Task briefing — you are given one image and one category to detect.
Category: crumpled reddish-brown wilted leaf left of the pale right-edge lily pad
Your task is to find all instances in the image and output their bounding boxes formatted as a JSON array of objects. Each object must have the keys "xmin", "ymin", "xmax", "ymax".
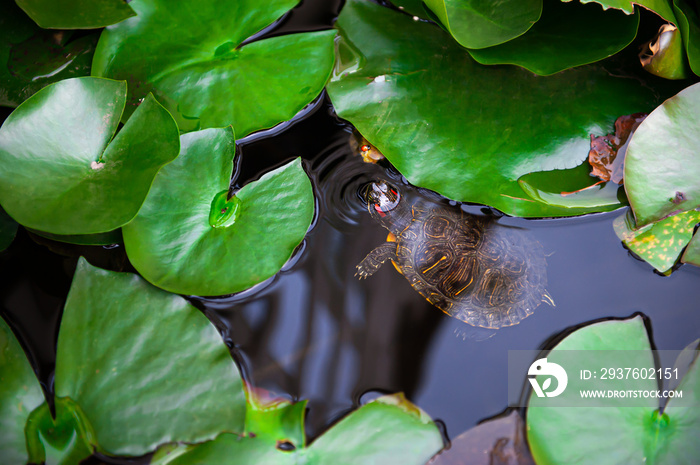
[{"xmin": 588, "ymin": 113, "xmax": 647, "ymax": 184}]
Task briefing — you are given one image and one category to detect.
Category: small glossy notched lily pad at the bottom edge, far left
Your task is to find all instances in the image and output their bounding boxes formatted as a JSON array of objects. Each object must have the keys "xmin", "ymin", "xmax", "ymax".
[{"xmin": 26, "ymin": 399, "xmax": 97, "ymax": 465}]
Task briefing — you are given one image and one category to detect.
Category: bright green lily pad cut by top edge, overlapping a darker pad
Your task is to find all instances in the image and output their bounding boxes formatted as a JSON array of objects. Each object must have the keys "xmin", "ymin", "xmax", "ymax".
[{"xmin": 424, "ymin": 0, "xmax": 542, "ymax": 48}]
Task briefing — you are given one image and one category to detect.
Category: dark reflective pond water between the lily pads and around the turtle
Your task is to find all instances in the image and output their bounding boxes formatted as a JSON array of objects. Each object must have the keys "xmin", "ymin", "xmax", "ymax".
[{"xmin": 0, "ymin": 0, "xmax": 700, "ymax": 460}]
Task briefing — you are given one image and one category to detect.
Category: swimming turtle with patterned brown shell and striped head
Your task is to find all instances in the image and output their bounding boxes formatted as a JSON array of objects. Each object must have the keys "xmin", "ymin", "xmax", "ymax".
[{"xmin": 357, "ymin": 181, "xmax": 553, "ymax": 329}]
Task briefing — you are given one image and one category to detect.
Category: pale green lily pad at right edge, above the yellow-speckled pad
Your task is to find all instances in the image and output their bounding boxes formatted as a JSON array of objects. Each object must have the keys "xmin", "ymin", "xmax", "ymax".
[{"xmin": 624, "ymin": 84, "xmax": 700, "ymax": 226}]
